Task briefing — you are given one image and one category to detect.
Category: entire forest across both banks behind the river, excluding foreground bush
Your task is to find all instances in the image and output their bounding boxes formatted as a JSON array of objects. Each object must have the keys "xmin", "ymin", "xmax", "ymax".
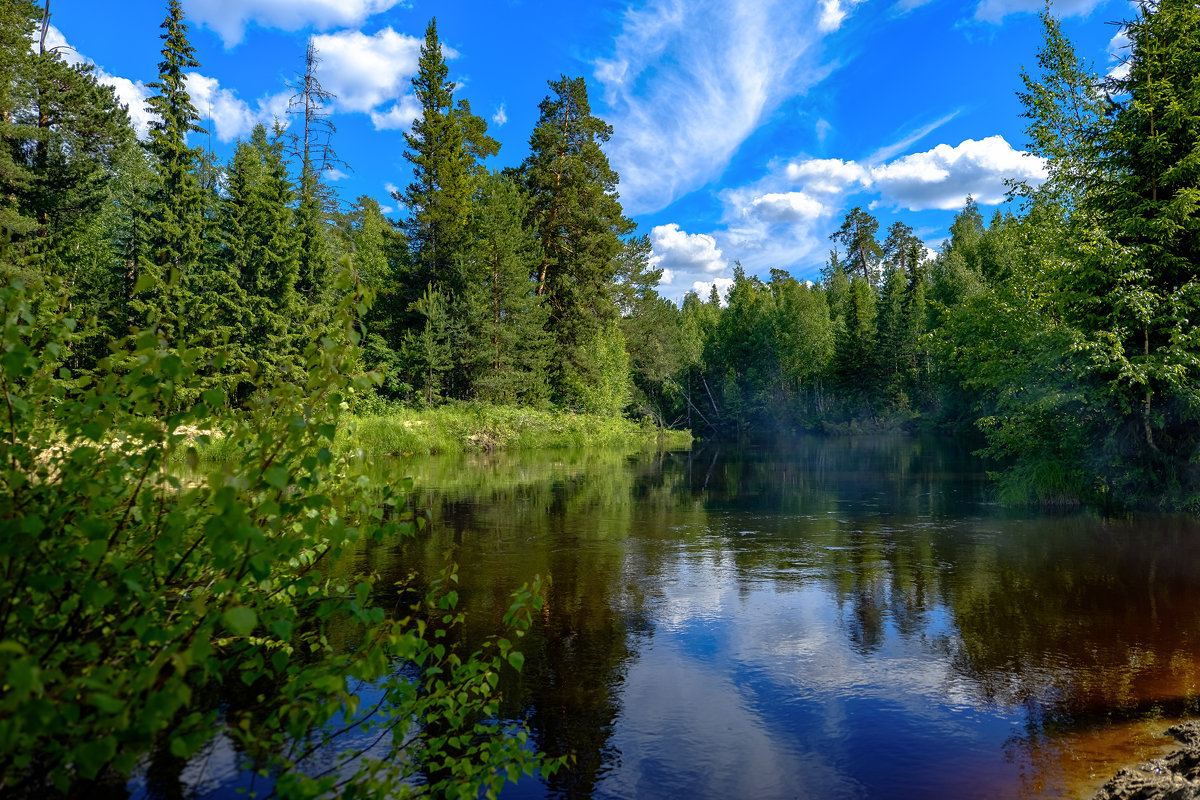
[{"xmin": 7, "ymin": 0, "xmax": 1200, "ymax": 510}]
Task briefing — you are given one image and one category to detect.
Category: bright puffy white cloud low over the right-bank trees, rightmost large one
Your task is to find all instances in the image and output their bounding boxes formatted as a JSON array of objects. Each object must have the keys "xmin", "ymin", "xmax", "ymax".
[{"xmin": 871, "ymin": 136, "xmax": 1045, "ymax": 211}]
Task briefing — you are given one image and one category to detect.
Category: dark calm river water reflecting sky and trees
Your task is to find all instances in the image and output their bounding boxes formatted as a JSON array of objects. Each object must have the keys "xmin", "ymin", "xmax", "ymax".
[{"xmin": 379, "ymin": 438, "xmax": 1200, "ymax": 799}]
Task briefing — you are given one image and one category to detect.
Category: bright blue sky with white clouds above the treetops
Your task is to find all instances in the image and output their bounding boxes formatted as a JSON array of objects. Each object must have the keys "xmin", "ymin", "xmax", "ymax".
[{"xmin": 50, "ymin": 0, "xmax": 1130, "ymax": 300}]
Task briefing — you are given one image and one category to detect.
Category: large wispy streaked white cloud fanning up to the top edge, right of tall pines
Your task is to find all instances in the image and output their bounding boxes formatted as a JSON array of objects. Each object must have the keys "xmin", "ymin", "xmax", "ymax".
[{"xmin": 594, "ymin": 0, "xmax": 852, "ymax": 213}]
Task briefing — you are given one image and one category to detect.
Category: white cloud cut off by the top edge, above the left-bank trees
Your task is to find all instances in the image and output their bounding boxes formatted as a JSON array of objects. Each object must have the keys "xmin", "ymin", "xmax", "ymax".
[{"xmin": 184, "ymin": 0, "xmax": 402, "ymax": 48}]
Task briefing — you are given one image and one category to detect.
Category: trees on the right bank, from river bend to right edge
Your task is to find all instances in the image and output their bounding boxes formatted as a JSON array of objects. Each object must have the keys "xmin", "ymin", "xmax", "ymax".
[{"xmin": 671, "ymin": 0, "xmax": 1200, "ymax": 510}]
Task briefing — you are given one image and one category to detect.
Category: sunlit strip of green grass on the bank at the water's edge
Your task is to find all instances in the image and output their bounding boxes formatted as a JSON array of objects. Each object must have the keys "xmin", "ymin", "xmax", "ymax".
[{"xmin": 337, "ymin": 403, "xmax": 691, "ymax": 456}]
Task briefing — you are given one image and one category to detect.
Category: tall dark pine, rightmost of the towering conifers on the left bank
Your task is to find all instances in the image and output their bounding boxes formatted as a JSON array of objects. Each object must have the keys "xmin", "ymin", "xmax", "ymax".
[{"xmin": 523, "ymin": 76, "xmax": 632, "ymax": 403}]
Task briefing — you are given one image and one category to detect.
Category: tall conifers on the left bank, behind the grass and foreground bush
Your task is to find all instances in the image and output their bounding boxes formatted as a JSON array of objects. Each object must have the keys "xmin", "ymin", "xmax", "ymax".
[{"xmin": 0, "ymin": 0, "xmax": 665, "ymax": 414}]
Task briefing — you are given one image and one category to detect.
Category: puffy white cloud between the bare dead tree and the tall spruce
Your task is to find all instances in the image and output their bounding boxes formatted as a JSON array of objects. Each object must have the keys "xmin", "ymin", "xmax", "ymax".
[{"xmin": 313, "ymin": 28, "xmax": 427, "ymax": 115}]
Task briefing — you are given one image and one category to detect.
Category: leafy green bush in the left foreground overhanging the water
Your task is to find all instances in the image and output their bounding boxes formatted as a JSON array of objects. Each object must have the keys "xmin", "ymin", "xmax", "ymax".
[{"xmin": 0, "ymin": 284, "xmax": 547, "ymax": 798}]
